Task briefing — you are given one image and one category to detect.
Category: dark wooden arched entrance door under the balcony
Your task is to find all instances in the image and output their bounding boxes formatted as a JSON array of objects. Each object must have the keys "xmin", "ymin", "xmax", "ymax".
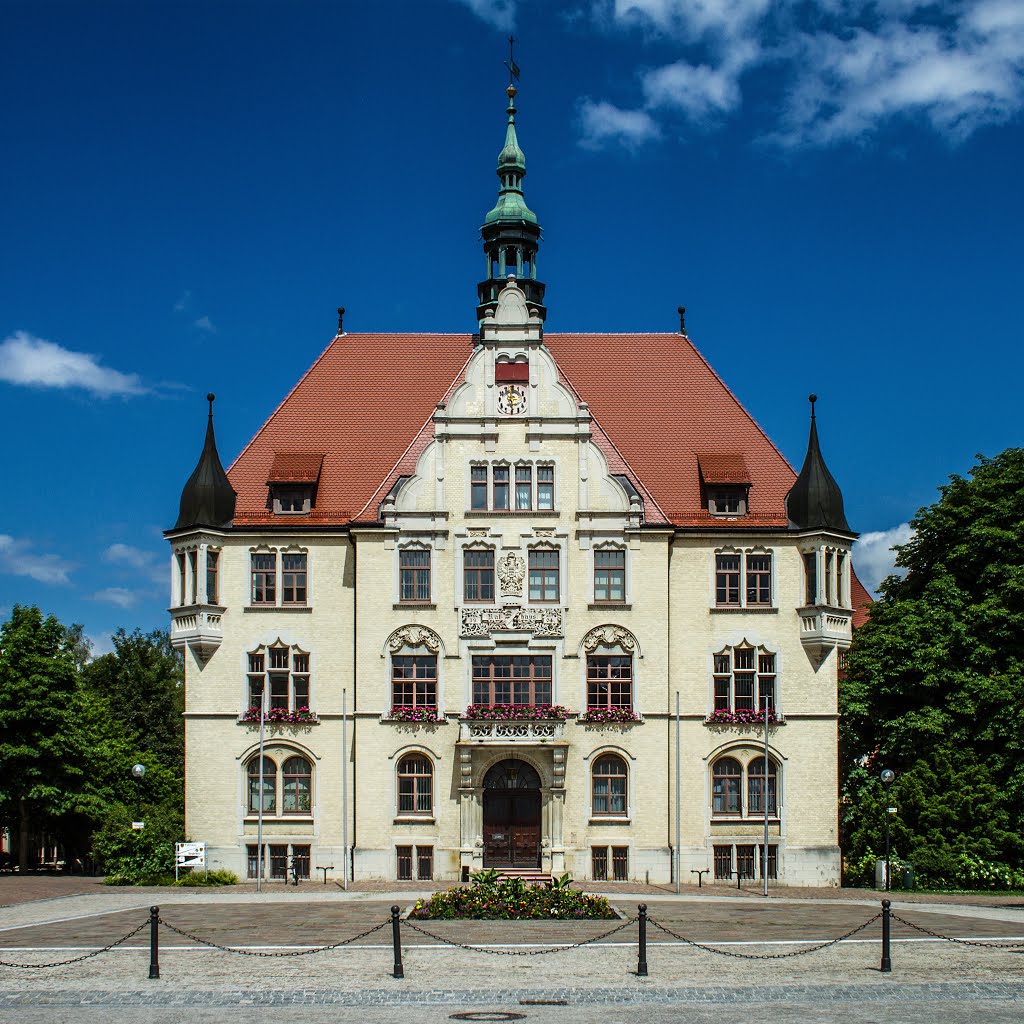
[{"xmin": 483, "ymin": 760, "xmax": 541, "ymax": 867}]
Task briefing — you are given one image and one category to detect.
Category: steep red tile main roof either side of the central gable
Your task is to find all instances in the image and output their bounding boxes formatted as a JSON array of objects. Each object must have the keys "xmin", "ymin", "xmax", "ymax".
[{"xmin": 228, "ymin": 334, "xmax": 796, "ymax": 528}]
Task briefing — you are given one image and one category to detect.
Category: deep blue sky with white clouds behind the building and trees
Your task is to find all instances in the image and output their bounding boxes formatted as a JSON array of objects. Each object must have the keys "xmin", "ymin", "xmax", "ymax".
[{"xmin": 0, "ymin": 0, "xmax": 1024, "ymax": 650}]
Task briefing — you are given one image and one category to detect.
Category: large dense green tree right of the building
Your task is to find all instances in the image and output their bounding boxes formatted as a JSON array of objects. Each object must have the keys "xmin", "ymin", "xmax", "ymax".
[{"xmin": 840, "ymin": 449, "xmax": 1024, "ymax": 878}]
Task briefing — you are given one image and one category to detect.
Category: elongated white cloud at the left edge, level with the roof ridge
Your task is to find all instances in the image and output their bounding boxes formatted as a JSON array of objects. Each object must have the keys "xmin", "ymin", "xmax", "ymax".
[{"xmin": 0, "ymin": 331, "xmax": 150, "ymax": 398}]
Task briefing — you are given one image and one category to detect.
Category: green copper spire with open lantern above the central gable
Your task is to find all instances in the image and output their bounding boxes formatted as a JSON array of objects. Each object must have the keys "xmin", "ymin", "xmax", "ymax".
[{"xmin": 476, "ymin": 80, "xmax": 547, "ymax": 319}]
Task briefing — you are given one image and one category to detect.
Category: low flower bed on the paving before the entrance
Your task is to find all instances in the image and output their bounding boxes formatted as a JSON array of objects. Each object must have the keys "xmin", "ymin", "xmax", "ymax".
[{"xmin": 409, "ymin": 879, "xmax": 617, "ymax": 921}]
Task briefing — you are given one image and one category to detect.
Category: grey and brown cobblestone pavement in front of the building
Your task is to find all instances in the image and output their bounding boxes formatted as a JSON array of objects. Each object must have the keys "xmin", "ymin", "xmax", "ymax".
[{"xmin": 0, "ymin": 880, "xmax": 1024, "ymax": 1024}]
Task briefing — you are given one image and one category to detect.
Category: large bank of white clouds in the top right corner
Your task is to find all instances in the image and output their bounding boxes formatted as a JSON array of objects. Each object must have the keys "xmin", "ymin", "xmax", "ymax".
[{"xmin": 581, "ymin": 0, "xmax": 1024, "ymax": 147}]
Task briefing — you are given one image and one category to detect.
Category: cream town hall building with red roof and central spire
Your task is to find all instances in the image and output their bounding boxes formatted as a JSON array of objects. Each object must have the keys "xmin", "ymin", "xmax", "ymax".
[{"xmin": 167, "ymin": 75, "xmax": 866, "ymax": 886}]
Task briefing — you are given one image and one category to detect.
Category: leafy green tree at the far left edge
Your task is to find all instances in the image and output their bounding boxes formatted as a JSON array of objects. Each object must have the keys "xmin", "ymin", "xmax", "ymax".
[{"xmin": 0, "ymin": 604, "xmax": 82, "ymax": 870}]
